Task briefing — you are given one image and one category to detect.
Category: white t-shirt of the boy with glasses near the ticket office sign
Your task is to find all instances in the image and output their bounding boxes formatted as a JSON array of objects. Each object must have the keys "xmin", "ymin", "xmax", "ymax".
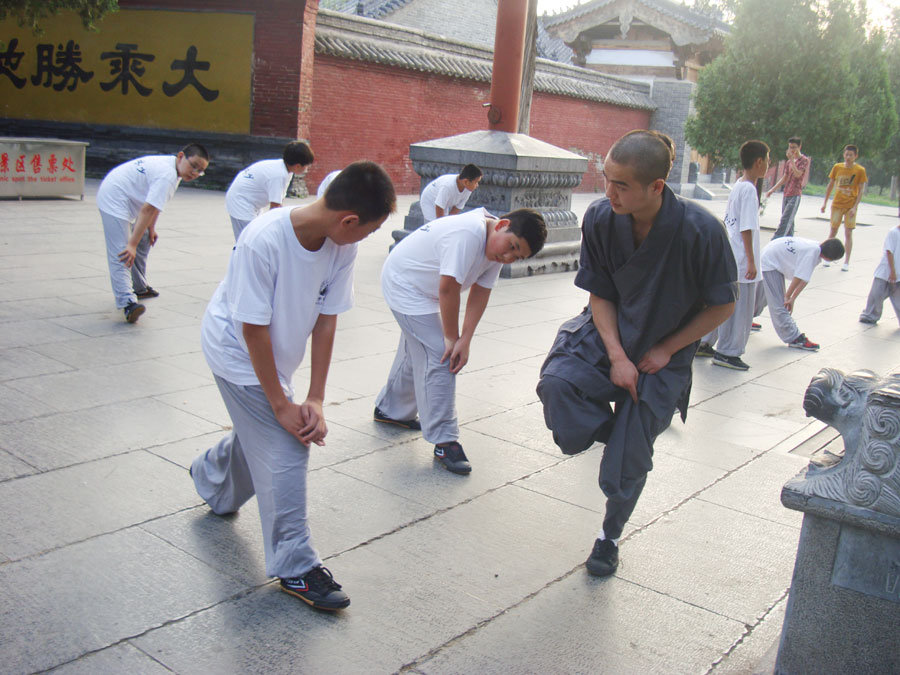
[{"xmin": 97, "ymin": 155, "xmax": 181, "ymax": 221}]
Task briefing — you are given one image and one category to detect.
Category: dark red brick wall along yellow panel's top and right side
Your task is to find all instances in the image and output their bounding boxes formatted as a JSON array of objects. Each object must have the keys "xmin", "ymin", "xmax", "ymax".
[{"xmin": 119, "ymin": 0, "xmax": 319, "ymax": 138}]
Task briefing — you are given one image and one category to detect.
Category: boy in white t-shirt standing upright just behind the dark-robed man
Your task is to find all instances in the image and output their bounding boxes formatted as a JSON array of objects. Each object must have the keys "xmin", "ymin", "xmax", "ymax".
[{"xmin": 697, "ymin": 141, "xmax": 769, "ymax": 370}]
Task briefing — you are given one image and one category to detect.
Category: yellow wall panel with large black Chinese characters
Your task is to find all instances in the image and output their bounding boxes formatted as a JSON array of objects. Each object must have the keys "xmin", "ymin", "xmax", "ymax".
[{"xmin": 0, "ymin": 9, "xmax": 253, "ymax": 134}]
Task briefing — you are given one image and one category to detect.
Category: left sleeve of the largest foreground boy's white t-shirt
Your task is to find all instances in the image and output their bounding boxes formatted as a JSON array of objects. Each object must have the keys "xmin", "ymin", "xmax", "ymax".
[{"xmin": 225, "ymin": 245, "xmax": 275, "ymax": 326}]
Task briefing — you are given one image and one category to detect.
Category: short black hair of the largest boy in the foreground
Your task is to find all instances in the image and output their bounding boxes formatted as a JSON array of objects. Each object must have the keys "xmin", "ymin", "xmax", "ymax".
[{"xmin": 325, "ymin": 161, "xmax": 397, "ymax": 225}]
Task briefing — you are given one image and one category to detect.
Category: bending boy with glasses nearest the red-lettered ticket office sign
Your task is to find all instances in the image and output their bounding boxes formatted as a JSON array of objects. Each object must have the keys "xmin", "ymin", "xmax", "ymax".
[{"xmin": 97, "ymin": 143, "xmax": 209, "ymax": 323}]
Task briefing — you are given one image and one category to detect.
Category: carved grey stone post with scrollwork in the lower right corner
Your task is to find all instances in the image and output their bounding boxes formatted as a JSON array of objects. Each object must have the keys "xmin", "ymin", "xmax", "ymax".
[{"xmin": 775, "ymin": 368, "xmax": 900, "ymax": 675}]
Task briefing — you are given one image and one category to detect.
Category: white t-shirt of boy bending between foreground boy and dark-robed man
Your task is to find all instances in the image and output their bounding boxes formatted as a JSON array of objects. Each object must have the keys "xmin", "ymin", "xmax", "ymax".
[{"xmin": 381, "ymin": 209, "xmax": 503, "ymax": 316}]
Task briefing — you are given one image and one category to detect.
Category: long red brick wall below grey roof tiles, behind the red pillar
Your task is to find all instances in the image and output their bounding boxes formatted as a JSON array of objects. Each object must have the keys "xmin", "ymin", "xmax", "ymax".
[{"xmin": 307, "ymin": 54, "xmax": 650, "ymax": 194}]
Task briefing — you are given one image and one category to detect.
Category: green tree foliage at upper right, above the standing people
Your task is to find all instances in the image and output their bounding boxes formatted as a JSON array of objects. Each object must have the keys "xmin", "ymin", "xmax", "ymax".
[{"xmin": 685, "ymin": 0, "xmax": 898, "ymax": 172}]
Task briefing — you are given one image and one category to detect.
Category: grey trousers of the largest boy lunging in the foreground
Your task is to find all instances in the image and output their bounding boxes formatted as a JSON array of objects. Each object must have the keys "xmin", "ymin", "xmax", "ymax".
[{"xmin": 191, "ymin": 376, "xmax": 322, "ymax": 579}]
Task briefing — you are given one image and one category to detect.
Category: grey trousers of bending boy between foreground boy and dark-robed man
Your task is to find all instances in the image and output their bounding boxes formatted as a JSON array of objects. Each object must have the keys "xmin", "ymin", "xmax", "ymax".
[{"xmin": 375, "ymin": 312, "xmax": 459, "ymax": 444}]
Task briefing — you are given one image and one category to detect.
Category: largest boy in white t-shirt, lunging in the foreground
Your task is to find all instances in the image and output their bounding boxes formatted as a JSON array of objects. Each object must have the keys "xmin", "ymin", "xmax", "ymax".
[{"xmin": 191, "ymin": 162, "xmax": 396, "ymax": 610}]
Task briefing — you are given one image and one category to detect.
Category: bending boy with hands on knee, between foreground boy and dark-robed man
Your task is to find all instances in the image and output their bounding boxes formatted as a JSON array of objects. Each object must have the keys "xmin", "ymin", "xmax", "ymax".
[{"xmin": 375, "ymin": 209, "xmax": 547, "ymax": 474}]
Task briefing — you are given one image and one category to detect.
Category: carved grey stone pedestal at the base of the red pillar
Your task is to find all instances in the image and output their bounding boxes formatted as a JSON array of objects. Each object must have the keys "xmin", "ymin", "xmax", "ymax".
[{"xmin": 393, "ymin": 131, "xmax": 588, "ymax": 277}]
